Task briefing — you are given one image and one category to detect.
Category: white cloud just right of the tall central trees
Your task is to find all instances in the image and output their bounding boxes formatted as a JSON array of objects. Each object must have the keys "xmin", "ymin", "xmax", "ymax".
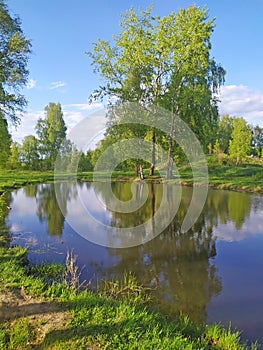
[{"xmin": 219, "ymin": 85, "xmax": 263, "ymax": 125}]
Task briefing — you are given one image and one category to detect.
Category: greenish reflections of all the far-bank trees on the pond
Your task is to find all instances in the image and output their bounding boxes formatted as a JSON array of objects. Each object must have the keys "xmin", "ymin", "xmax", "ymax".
[{"xmin": 13, "ymin": 182, "xmax": 251, "ymax": 322}]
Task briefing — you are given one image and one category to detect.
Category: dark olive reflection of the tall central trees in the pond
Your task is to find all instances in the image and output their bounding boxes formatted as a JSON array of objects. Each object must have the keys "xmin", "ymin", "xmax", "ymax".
[{"xmin": 98, "ymin": 184, "xmax": 222, "ymax": 322}]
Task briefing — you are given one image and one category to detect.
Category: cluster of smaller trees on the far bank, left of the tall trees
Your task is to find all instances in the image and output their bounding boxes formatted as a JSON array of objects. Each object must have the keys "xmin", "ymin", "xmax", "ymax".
[{"xmin": 3, "ymin": 102, "xmax": 84, "ymax": 171}]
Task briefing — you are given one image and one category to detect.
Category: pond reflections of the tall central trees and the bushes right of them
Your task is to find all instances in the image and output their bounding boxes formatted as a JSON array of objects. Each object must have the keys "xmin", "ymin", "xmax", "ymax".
[{"xmin": 92, "ymin": 183, "xmax": 251, "ymax": 322}]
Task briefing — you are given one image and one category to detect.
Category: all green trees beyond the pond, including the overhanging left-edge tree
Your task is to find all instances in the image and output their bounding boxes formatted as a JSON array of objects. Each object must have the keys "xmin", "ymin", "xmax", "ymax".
[{"xmin": 0, "ymin": 0, "xmax": 263, "ymax": 173}]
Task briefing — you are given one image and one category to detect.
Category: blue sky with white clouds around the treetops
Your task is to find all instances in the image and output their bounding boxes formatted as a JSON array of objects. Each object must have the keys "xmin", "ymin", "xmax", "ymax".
[{"xmin": 7, "ymin": 0, "xmax": 263, "ymax": 141}]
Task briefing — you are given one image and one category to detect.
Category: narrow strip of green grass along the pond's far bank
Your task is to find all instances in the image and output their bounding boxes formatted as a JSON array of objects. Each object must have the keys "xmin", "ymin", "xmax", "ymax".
[{"xmin": 0, "ymin": 161, "xmax": 263, "ymax": 194}]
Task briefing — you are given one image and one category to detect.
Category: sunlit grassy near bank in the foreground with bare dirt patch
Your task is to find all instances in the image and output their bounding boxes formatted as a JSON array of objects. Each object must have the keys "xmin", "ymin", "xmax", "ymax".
[{"xmin": 0, "ymin": 247, "xmax": 256, "ymax": 350}]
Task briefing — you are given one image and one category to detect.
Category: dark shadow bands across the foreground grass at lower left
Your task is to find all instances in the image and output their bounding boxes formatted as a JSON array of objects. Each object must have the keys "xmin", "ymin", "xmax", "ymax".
[{"xmin": 0, "ymin": 291, "xmax": 146, "ymax": 349}]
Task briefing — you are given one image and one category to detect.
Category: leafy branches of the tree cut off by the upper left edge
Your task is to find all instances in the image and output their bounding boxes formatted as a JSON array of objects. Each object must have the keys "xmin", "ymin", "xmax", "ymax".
[{"xmin": 0, "ymin": 0, "xmax": 31, "ymax": 123}]
